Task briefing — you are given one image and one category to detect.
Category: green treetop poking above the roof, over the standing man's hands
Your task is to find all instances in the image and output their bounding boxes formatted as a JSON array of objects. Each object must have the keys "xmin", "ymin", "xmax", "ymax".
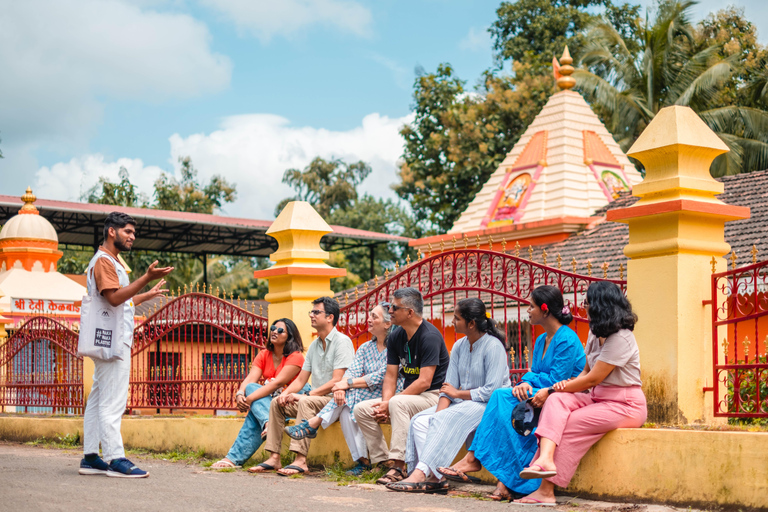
[{"xmin": 152, "ymin": 156, "xmax": 237, "ymax": 214}]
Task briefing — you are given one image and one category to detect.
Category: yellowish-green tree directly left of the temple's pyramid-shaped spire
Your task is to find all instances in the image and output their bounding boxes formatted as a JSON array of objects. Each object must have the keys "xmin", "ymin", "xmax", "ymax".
[{"xmin": 394, "ymin": 62, "xmax": 554, "ymax": 233}]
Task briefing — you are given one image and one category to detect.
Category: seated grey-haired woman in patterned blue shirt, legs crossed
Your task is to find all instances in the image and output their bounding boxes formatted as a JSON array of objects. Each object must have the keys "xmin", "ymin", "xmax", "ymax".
[{"xmin": 285, "ymin": 302, "xmax": 403, "ymax": 476}]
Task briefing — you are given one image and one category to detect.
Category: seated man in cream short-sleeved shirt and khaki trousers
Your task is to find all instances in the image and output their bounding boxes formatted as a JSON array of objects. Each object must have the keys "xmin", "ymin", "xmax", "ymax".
[{"xmin": 255, "ymin": 297, "xmax": 355, "ymax": 476}]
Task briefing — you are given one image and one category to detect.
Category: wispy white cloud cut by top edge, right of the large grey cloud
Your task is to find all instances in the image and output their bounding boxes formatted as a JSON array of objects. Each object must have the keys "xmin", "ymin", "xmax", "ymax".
[{"xmin": 199, "ymin": 0, "xmax": 372, "ymax": 43}]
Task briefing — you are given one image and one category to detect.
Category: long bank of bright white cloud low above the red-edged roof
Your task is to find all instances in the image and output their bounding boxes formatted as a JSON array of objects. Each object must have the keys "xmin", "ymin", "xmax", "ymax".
[{"xmin": 35, "ymin": 113, "xmax": 412, "ymax": 219}]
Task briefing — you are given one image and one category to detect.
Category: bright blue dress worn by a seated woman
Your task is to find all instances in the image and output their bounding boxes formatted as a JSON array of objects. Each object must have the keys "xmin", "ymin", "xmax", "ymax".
[{"xmin": 469, "ymin": 325, "xmax": 586, "ymax": 495}]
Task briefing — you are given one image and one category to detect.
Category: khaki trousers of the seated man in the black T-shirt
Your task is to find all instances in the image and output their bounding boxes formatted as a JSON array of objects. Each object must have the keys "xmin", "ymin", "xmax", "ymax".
[{"xmin": 355, "ymin": 389, "xmax": 440, "ymax": 464}]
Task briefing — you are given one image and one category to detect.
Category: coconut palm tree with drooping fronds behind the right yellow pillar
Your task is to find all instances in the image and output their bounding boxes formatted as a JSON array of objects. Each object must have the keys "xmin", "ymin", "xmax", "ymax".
[{"xmin": 573, "ymin": 0, "xmax": 768, "ymax": 176}]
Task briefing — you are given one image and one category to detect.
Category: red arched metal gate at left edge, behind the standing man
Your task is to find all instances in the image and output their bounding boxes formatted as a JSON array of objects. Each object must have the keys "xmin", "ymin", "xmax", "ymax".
[{"xmin": 0, "ymin": 316, "xmax": 83, "ymax": 414}]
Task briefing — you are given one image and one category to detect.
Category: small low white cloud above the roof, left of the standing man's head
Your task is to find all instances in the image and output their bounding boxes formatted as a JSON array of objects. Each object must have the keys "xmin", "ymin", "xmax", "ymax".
[{"xmin": 33, "ymin": 154, "xmax": 163, "ymax": 201}]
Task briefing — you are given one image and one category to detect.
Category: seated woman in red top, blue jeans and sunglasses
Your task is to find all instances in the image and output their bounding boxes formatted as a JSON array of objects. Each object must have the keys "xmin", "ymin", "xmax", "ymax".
[{"xmin": 211, "ymin": 318, "xmax": 304, "ymax": 469}]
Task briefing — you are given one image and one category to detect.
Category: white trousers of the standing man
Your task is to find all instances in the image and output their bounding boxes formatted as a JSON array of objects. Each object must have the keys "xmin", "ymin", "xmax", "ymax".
[{"xmin": 83, "ymin": 348, "xmax": 131, "ymax": 462}]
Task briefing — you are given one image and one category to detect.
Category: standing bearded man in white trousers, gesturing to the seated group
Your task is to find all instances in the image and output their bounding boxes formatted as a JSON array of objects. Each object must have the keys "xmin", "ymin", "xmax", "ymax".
[{"xmin": 79, "ymin": 212, "xmax": 173, "ymax": 478}]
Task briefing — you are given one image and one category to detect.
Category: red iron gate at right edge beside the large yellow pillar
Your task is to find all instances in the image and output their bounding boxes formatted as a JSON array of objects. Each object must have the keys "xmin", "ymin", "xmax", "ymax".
[{"xmin": 711, "ymin": 258, "xmax": 768, "ymax": 418}]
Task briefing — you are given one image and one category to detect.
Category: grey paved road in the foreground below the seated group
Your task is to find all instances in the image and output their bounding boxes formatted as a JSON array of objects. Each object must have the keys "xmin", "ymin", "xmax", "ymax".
[{"xmin": 0, "ymin": 442, "xmax": 674, "ymax": 512}]
